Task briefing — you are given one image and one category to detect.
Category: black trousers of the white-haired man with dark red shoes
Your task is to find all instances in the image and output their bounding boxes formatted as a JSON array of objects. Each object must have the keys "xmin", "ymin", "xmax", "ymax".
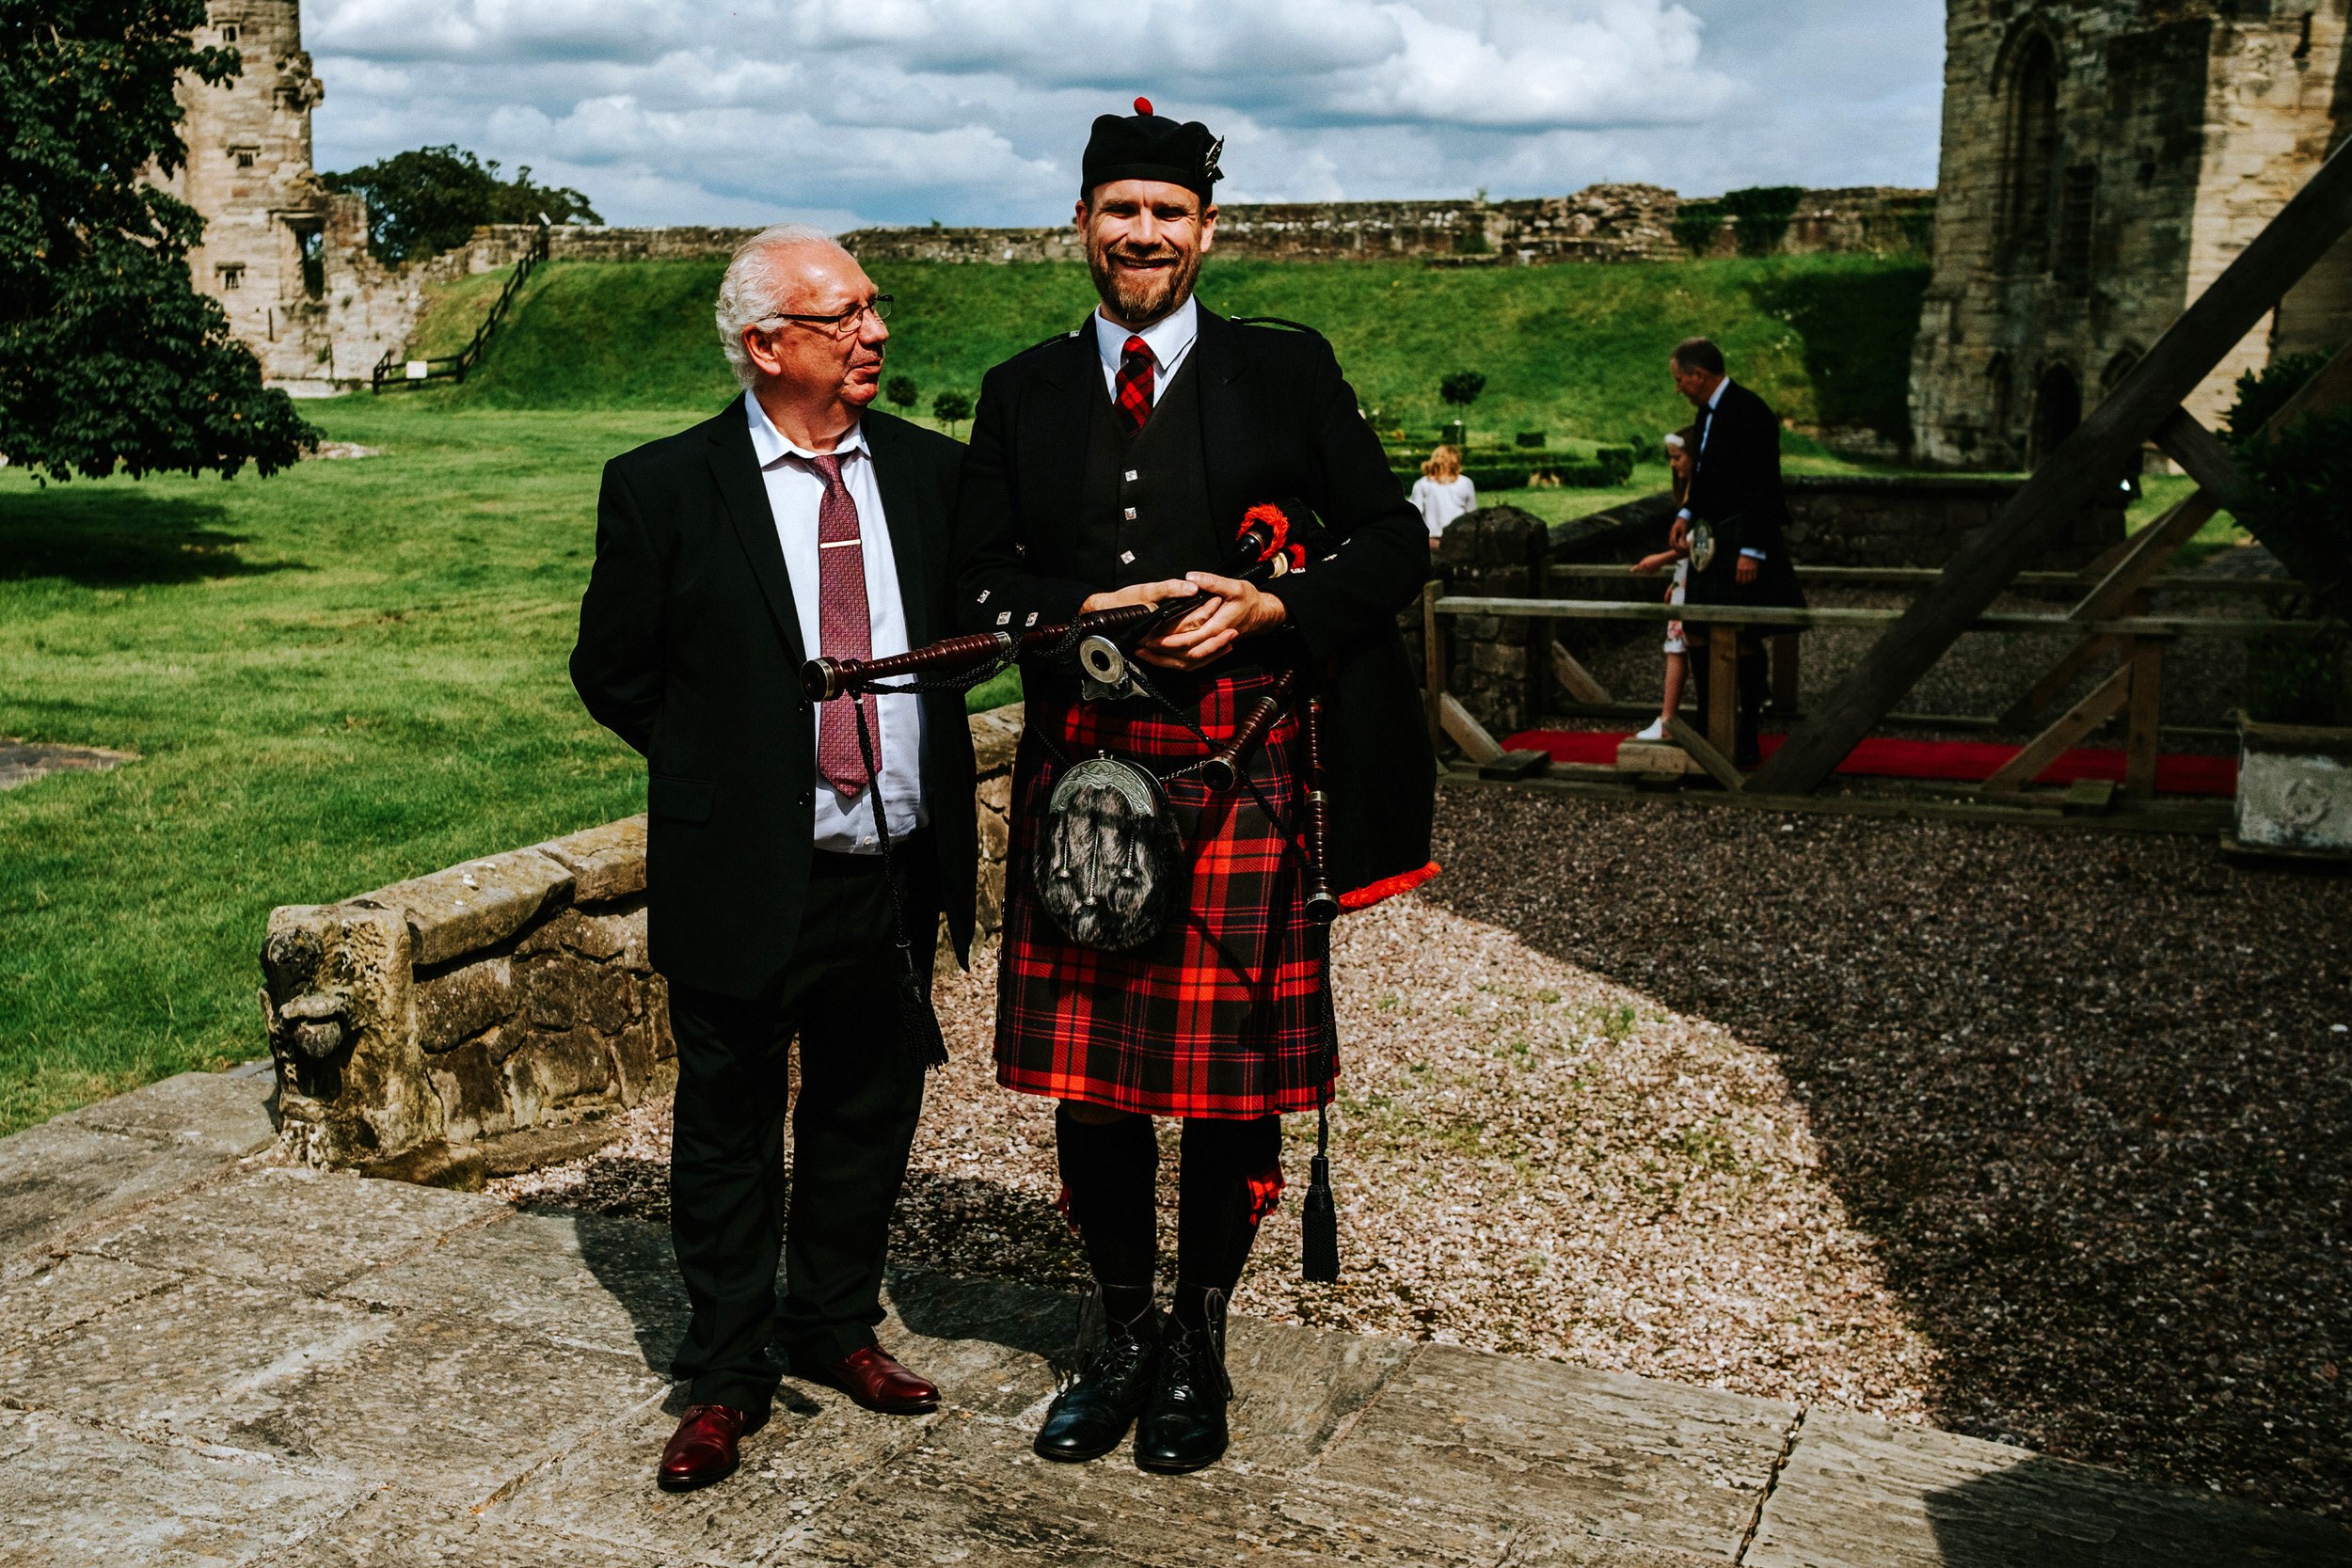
[{"xmin": 671, "ymin": 832, "xmax": 939, "ymax": 1416}]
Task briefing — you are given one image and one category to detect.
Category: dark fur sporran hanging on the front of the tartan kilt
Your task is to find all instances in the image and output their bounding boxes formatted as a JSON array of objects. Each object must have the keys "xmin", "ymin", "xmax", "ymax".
[{"xmin": 1030, "ymin": 757, "xmax": 1184, "ymax": 952}]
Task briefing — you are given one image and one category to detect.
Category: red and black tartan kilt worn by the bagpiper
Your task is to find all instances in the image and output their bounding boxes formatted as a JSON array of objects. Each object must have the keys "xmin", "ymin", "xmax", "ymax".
[{"xmin": 997, "ymin": 674, "xmax": 1336, "ymax": 1119}]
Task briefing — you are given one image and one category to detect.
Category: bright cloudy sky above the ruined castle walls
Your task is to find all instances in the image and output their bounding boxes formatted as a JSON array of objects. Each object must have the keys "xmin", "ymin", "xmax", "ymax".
[{"xmin": 304, "ymin": 0, "xmax": 1943, "ymax": 228}]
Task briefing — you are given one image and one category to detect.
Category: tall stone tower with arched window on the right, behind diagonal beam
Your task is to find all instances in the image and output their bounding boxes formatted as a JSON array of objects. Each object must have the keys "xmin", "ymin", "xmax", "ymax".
[{"xmin": 1910, "ymin": 0, "xmax": 2352, "ymax": 467}]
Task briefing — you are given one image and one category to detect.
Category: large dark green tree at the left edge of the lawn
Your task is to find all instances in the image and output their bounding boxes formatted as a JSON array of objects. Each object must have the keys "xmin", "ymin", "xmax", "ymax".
[{"xmin": 0, "ymin": 0, "xmax": 318, "ymax": 480}]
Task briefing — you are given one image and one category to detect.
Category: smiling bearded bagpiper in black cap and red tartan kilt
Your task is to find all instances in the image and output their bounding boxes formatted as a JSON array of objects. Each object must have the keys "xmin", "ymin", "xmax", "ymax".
[{"xmin": 958, "ymin": 99, "xmax": 1435, "ymax": 1472}]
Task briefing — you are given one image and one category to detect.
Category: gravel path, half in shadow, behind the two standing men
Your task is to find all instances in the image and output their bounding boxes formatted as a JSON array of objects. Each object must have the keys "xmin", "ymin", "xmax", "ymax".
[{"xmin": 501, "ymin": 790, "xmax": 2352, "ymax": 1514}]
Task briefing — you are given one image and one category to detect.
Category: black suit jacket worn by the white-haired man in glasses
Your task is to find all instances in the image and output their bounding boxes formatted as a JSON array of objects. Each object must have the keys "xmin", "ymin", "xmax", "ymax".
[{"xmin": 572, "ymin": 400, "xmax": 978, "ymax": 997}]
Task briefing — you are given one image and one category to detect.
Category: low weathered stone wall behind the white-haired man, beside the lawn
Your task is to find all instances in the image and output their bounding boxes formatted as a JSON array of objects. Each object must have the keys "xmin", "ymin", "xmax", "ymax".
[{"xmin": 262, "ymin": 707, "xmax": 1021, "ymax": 1182}]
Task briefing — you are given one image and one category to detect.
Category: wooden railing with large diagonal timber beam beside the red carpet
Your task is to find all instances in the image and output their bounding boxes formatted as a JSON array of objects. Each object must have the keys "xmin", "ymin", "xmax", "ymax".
[{"xmin": 1423, "ymin": 143, "xmax": 2352, "ymax": 800}]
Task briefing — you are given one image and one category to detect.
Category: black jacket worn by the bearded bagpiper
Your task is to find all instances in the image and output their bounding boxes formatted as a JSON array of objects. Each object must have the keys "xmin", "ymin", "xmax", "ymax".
[{"xmin": 955, "ymin": 310, "xmax": 1438, "ymax": 889}]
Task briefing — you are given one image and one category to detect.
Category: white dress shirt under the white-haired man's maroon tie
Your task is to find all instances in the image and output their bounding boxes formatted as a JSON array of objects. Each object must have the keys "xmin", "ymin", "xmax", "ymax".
[{"xmin": 743, "ymin": 392, "xmax": 931, "ymax": 853}]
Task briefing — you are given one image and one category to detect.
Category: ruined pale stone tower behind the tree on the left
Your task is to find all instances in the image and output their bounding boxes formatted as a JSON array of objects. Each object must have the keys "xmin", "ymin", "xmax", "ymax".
[{"xmin": 163, "ymin": 0, "xmax": 421, "ymax": 392}]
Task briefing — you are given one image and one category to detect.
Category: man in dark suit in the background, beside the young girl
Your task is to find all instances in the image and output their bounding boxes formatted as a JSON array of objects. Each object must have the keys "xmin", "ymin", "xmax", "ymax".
[{"xmin": 1665, "ymin": 339, "xmax": 1804, "ymax": 768}]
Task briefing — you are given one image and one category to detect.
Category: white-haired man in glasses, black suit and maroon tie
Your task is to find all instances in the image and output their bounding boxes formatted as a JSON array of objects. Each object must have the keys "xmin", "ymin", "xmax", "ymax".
[{"xmin": 572, "ymin": 226, "xmax": 977, "ymax": 1491}]
